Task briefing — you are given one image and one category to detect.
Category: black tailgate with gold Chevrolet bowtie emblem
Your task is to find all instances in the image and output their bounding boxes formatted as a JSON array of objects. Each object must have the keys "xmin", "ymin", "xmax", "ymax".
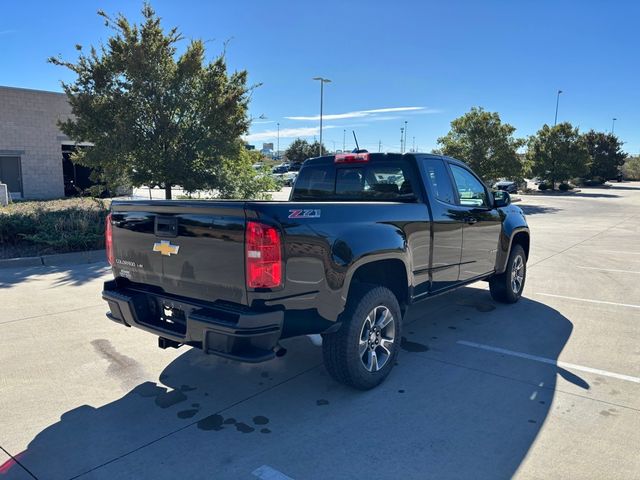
[{"xmin": 111, "ymin": 201, "xmax": 247, "ymax": 304}]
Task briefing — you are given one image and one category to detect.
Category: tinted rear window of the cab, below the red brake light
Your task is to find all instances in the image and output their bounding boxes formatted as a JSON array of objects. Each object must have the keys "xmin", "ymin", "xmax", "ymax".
[{"xmin": 291, "ymin": 161, "xmax": 417, "ymax": 201}]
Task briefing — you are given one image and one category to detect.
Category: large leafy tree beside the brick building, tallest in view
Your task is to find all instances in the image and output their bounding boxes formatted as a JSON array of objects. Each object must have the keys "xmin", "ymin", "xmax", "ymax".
[{"xmin": 49, "ymin": 4, "xmax": 250, "ymax": 198}]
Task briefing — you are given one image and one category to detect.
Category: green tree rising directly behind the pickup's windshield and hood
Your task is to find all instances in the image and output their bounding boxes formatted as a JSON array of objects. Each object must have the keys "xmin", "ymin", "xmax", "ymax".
[{"xmin": 438, "ymin": 107, "xmax": 525, "ymax": 179}]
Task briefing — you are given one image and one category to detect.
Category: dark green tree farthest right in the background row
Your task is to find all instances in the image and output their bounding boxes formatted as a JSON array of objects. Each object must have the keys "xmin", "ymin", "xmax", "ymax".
[{"xmin": 584, "ymin": 130, "xmax": 627, "ymax": 182}]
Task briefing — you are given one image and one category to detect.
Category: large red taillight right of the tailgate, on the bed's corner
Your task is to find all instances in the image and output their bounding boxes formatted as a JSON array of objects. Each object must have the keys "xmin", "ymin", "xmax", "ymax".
[{"xmin": 245, "ymin": 222, "xmax": 282, "ymax": 288}]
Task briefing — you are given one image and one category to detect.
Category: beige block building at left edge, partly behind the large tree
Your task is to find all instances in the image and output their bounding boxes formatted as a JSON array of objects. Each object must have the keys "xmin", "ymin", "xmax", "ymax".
[{"xmin": 0, "ymin": 86, "xmax": 81, "ymax": 199}]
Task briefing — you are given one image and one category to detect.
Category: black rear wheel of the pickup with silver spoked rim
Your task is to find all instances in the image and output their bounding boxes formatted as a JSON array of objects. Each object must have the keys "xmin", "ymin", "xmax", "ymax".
[{"xmin": 322, "ymin": 284, "xmax": 402, "ymax": 390}]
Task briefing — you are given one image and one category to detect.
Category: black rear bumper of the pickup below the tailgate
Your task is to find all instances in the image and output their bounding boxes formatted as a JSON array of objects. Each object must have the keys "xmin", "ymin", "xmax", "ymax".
[{"xmin": 102, "ymin": 280, "xmax": 283, "ymax": 363}]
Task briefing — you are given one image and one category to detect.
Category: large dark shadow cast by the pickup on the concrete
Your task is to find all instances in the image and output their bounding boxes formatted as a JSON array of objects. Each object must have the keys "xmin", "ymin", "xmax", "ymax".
[{"xmin": 0, "ymin": 288, "xmax": 589, "ymax": 479}]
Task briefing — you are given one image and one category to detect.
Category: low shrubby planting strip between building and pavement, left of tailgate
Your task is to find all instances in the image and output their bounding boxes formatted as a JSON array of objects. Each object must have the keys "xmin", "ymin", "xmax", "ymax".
[{"xmin": 0, "ymin": 198, "xmax": 109, "ymax": 258}]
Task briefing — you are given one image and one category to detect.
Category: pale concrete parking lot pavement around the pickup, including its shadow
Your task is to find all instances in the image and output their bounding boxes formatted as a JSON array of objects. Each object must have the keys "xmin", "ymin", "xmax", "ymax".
[{"xmin": 0, "ymin": 182, "xmax": 640, "ymax": 480}]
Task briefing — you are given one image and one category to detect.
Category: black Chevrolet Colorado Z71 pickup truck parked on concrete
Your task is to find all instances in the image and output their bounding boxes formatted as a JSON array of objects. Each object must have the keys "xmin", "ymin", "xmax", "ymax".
[{"xmin": 102, "ymin": 152, "xmax": 530, "ymax": 389}]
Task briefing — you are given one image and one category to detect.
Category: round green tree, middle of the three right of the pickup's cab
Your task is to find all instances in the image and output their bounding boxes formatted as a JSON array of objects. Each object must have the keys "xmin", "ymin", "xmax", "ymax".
[{"xmin": 527, "ymin": 122, "xmax": 589, "ymax": 189}]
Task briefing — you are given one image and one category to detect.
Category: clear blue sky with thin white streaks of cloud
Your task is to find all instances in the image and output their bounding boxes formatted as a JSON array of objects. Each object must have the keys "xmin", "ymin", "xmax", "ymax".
[{"xmin": 0, "ymin": 0, "xmax": 640, "ymax": 153}]
